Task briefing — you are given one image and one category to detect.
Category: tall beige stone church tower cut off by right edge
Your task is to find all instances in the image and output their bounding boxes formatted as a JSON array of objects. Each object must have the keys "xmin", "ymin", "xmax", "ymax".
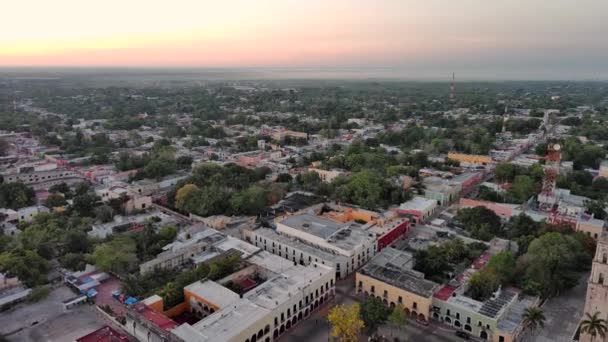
[{"xmin": 580, "ymin": 235, "xmax": 608, "ymax": 342}]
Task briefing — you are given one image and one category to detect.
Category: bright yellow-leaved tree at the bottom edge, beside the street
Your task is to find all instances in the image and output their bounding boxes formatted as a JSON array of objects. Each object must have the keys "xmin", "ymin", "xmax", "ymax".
[{"xmin": 327, "ymin": 303, "xmax": 365, "ymax": 342}]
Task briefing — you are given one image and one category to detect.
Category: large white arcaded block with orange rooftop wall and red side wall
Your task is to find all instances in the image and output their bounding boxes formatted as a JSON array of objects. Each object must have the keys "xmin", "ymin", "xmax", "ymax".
[{"xmin": 248, "ymin": 203, "xmax": 409, "ymax": 278}]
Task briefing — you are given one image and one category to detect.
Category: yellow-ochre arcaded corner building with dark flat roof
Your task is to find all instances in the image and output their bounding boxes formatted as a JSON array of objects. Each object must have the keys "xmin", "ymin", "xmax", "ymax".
[{"xmin": 355, "ymin": 247, "xmax": 439, "ymax": 321}]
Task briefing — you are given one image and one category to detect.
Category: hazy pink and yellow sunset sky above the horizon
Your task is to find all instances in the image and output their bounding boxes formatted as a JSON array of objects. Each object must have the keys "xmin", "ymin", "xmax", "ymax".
[{"xmin": 0, "ymin": 0, "xmax": 608, "ymax": 79}]
